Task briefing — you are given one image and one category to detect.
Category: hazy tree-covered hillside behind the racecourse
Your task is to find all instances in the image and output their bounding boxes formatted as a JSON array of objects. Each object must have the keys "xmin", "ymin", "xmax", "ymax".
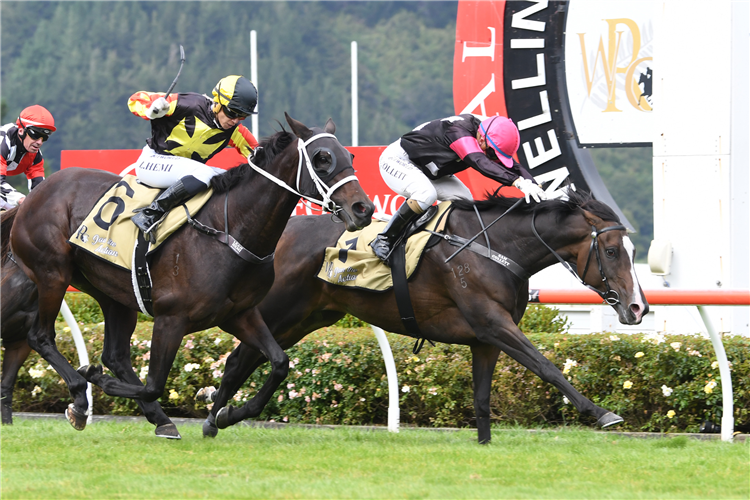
[{"xmin": 0, "ymin": 0, "xmax": 653, "ymax": 248}]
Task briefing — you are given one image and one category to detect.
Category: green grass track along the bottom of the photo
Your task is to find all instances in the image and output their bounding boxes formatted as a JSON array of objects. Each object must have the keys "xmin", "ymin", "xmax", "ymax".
[{"xmin": 0, "ymin": 419, "xmax": 750, "ymax": 500}]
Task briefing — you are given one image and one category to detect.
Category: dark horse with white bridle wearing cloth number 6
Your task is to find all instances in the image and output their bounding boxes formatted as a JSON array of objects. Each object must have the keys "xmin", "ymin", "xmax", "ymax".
[{"xmin": 10, "ymin": 115, "xmax": 374, "ymax": 437}]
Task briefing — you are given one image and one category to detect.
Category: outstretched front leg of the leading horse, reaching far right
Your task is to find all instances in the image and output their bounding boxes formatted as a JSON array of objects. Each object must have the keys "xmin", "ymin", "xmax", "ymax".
[{"xmin": 472, "ymin": 311, "xmax": 622, "ymax": 427}]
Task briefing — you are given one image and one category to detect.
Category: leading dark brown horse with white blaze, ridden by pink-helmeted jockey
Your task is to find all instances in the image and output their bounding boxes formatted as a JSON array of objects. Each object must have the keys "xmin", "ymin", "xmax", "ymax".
[{"xmin": 199, "ymin": 192, "xmax": 648, "ymax": 443}]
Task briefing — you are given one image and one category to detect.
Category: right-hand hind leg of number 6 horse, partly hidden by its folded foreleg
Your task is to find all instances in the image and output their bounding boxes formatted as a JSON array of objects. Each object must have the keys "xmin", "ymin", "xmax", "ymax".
[{"xmin": 96, "ymin": 294, "xmax": 180, "ymax": 439}]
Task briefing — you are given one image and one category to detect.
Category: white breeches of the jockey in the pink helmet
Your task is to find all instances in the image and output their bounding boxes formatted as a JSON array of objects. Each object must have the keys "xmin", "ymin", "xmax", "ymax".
[{"xmin": 379, "ymin": 139, "xmax": 472, "ymax": 210}]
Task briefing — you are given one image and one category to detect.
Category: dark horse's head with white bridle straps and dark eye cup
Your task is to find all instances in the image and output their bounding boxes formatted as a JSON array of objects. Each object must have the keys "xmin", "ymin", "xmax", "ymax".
[{"xmin": 284, "ymin": 113, "xmax": 375, "ymax": 231}]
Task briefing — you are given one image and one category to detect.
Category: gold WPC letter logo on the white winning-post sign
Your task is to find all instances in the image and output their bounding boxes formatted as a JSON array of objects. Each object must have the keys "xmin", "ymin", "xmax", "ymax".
[{"xmin": 578, "ymin": 18, "xmax": 653, "ymax": 113}]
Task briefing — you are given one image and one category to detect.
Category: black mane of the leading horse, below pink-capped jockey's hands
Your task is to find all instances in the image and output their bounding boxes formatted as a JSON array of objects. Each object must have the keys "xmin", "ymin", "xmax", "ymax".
[{"xmin": 453, "ymin": 189, "xmax": 620, "ymax": 224}]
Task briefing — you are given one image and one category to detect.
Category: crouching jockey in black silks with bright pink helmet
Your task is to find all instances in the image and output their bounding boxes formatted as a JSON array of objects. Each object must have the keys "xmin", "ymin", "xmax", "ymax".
[{"xmin": 370, "ymin": 114, "xmax": 547, "ymax": 262}]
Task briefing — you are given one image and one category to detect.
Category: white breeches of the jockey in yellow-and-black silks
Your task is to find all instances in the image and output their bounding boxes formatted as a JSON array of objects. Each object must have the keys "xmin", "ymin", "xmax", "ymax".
[{"xmin": 135, "ymin": 146, "xmax": 224, "ymax": 188}]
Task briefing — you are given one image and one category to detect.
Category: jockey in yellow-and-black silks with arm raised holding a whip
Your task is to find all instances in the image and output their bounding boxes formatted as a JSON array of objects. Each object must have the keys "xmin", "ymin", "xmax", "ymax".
[{"xmin": 128, "ymin": 75, "xmax": 258, "ymax": 242}]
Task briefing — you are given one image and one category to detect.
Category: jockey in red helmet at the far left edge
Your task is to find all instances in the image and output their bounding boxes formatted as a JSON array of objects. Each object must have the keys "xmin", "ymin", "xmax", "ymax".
[{"xmin": 0, "ymin": 104, "xmax": 57, "ymax": 210}]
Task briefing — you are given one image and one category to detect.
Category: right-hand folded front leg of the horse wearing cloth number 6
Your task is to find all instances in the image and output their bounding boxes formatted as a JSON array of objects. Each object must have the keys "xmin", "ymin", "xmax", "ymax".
[{"xmin": 216, "ymin": 307, "xmax": 289, "ymax": 429}]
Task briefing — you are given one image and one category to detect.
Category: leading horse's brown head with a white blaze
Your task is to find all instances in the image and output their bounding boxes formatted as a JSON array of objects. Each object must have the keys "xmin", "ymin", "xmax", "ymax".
[{"xmin": 576, "ymin": 204, "xmax": 648, "ymax": 325}]
